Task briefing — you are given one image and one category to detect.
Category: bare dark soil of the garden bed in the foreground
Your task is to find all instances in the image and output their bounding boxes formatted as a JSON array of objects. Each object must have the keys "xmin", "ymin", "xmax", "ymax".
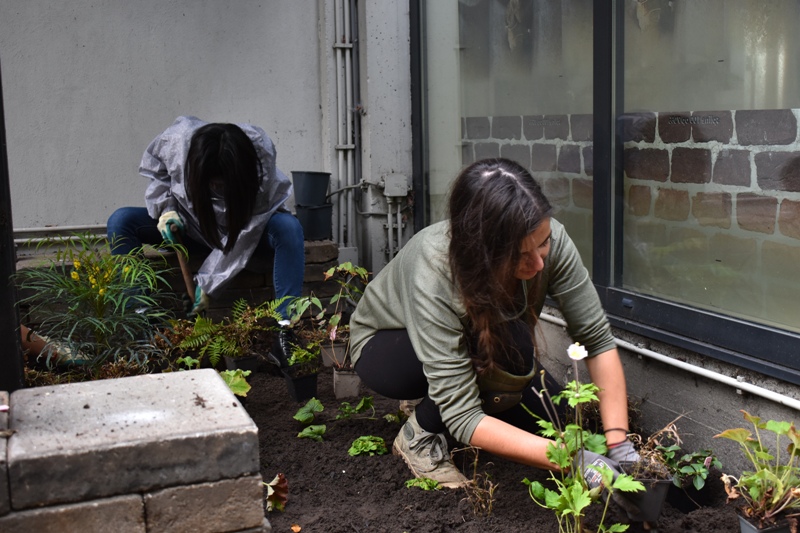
[{"xmin": 245, "ymin": 368, "xmax": 739, "ymax": 533}]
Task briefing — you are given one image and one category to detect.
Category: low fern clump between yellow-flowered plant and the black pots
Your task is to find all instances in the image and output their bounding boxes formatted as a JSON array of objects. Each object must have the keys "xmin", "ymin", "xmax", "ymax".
[{"xmin": 172, "ymin": 298, "xmax": 285, "ymax": 366}]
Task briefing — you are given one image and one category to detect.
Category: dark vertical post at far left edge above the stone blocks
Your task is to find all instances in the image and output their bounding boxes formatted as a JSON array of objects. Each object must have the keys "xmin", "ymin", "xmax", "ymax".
[{"xmin": 0, "ymin": 60, "xmax": 24, "ymax": 393}]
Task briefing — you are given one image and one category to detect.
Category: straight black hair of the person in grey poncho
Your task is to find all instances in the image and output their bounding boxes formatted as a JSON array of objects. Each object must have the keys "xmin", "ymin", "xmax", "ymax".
[{"xmin": 186, "ymin": 124, "xmax": 261, "ymax": 253}]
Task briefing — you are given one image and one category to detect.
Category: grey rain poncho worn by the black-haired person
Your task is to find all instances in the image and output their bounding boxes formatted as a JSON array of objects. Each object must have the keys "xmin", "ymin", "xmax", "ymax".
[{"xmin": 139, "ymin": 117, "xmax": 292, "ymax": 296}]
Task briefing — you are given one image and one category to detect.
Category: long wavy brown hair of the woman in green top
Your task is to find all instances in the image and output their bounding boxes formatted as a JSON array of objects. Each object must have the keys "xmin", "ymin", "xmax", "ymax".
[{"xmin": 449, "ymin": 159, "xmax": 552, "ymax": 373}]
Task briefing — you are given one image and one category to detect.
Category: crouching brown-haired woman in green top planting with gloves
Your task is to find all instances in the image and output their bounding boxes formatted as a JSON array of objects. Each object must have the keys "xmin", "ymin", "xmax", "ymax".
[{"xmin": 350, "ymin": 159, "xmax": 635, "ymax": 487}]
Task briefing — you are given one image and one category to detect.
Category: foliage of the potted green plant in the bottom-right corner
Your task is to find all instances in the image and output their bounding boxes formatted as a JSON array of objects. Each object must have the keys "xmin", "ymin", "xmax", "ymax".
[{"xmin": 714, "ymin": 410, "xmax": 800, "ymax": 528}]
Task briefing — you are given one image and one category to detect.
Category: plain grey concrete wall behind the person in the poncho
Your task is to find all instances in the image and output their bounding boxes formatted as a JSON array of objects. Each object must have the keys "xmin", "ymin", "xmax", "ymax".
[{"xmin": 0, "ymin": 0, "xmax": 333, "ymax": 228}]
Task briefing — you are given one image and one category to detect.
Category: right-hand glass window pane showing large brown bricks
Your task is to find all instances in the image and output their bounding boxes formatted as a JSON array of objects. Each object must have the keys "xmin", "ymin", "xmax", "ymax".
[{"xmin": 618, "ymin": 0, "xmax": 800, "ymax": 331}]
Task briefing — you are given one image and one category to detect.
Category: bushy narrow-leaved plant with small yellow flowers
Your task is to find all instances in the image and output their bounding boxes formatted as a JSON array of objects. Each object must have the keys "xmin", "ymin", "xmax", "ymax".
[{"xmin": 16, "ymin": 234, "xmax": 172, "ymax": 370}]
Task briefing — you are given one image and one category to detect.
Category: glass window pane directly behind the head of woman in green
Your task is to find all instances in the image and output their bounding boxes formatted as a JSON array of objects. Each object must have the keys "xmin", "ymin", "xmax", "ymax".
[{"xmin": 423, "ymin": 0, "xmax": 593, "ymax": 266}]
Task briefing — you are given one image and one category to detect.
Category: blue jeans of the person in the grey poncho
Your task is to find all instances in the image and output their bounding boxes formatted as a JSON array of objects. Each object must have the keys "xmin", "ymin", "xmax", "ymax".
[{"xmin": 106, "ymin": 207, "xmax": 305, "ymax": 318}]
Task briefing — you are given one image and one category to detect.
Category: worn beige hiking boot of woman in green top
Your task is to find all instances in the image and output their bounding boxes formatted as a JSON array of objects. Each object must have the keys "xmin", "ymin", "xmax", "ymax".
[{"xmin": 392, "ymin": 412, "xmax": 467, "ymax": 489}]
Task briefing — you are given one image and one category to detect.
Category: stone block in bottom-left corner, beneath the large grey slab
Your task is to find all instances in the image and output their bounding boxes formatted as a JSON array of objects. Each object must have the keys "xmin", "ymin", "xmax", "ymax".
[{"xmin": 0, "ymin": 495, "xmax": 145, "ymax": 533}]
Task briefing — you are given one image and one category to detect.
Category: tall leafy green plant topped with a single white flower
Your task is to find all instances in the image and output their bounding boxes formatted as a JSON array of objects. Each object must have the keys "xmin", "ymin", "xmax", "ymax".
[{"xmin": 523, "ymin": 344, "xmax": 644, "ymax": 533}]
